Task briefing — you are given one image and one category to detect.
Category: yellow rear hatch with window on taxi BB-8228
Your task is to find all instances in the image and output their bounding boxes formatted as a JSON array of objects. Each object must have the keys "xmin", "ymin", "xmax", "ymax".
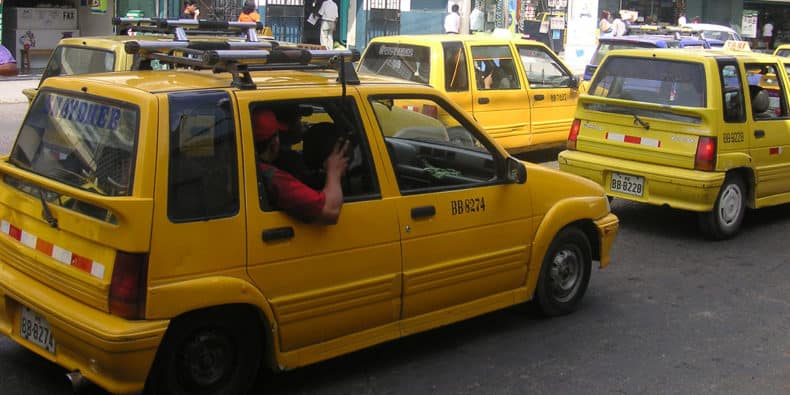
[{"xmin": 568, "ymin": 57, "xmax": 716, "ymax": 169}]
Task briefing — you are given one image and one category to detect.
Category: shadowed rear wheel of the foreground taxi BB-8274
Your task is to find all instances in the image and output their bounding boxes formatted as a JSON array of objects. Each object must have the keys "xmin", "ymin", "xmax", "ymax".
[{"xmin": 145, "ymin": 306, "xmax": 263, "ymax": 395}]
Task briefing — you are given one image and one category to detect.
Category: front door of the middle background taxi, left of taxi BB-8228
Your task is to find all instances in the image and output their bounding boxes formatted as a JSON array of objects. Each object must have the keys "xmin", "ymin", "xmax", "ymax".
[{"xmin": 517, "ymin": 44, "xmax": 579, "ymax": 145}]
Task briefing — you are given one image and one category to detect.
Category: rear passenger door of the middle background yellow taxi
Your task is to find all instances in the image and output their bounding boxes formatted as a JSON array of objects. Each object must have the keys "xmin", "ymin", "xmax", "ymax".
[{"xmin": 469, "ymin": 43, "xmax": 531, "ymax": 149}]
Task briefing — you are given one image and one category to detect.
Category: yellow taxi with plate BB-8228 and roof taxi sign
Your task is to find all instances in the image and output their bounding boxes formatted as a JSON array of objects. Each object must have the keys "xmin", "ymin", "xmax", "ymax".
[{"xmin": 558, "ymin": 46, "xmax": 790, "ymax": 239}]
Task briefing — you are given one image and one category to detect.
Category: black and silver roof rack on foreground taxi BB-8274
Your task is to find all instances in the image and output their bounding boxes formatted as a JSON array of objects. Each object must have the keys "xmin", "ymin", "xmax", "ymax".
[{"xmin": 125, "ymin": 41, "xmax": 360, "ymax": 89}]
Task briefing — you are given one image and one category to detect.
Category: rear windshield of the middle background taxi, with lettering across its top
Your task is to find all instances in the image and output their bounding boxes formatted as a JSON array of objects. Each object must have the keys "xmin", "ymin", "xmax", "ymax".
[{"xmin": 360, "ymin": 43, "xmax": 431, "ymax": 84}]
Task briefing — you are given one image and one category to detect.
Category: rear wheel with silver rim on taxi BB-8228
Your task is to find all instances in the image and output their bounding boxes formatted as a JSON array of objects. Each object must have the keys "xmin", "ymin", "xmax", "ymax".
[{"xmin": 699, "ymin": 175, "xmax": 747, "ymax": 240}]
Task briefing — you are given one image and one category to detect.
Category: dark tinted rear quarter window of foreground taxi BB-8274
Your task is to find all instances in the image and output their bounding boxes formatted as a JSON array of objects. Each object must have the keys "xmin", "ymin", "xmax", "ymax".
[{"xmin": 167, "ymin": 92, "xmax": 239, "ymax": 222}]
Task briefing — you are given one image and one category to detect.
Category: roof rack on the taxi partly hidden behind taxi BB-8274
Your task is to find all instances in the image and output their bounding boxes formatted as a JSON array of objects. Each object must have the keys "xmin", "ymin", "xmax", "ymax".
[{"xmin": 112, "ymin": 17, "xmax": 263, "ymax": 42}]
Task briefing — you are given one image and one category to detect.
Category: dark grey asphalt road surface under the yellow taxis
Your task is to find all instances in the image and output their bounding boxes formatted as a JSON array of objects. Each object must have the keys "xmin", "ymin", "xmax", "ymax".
[{"xmin": 0, "ymin": 105, "xmax": 790, "ymax": 395}]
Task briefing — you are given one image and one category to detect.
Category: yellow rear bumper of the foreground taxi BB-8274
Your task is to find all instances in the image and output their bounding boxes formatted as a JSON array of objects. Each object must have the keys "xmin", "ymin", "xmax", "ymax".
[{"xmin": 0, "ymin": 262, "xmax": 168, "ymax": 394}]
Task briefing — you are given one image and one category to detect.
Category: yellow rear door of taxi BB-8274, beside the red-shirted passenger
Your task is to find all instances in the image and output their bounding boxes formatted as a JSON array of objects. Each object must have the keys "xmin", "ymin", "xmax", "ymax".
[{"xmin": 237, "ymin": 88, "xmax": 401, "ymax": 356}]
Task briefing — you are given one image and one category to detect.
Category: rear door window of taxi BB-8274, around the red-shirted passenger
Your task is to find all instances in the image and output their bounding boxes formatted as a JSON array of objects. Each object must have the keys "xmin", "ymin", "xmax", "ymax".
[{"xmin": 247, "ymin": 97, "xmax": 381, "ymax": 211}]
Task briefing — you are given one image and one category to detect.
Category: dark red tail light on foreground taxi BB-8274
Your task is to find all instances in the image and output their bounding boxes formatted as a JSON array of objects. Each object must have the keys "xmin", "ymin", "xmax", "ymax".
[{"xmin": 110, "ymin": 251, "xmax": 148, "ymax": 320}]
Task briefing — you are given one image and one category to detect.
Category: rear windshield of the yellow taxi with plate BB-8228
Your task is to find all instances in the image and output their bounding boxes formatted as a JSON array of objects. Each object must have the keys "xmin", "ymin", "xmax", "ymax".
[{"xmin": 588, "ymin": 56, "xmax": 707, "ymax": 107}]
